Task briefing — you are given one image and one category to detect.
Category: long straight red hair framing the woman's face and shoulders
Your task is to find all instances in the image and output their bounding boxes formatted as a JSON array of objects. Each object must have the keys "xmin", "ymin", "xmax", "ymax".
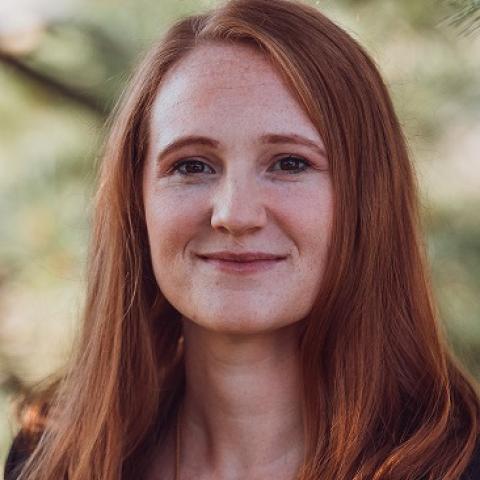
[{"xmin": 13, "ymin": 0, "xmax": 480, "ymax": 480}]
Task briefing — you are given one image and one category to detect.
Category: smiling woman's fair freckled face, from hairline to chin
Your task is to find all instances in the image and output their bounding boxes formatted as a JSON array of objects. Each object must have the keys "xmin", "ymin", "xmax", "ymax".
[{"xmin": 143, "ymin": 44, "xmax": 333, "ymax": 334}]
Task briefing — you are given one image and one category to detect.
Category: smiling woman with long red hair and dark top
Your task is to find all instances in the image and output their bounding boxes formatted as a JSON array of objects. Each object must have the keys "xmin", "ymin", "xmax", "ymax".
[{"xmin": 7, "ymin": 0, "xmax": 480, "ymax": 480}]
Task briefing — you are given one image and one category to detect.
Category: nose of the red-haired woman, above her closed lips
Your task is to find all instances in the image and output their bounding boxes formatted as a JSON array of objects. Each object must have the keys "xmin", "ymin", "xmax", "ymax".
[{"xmin": 211, "ymin": 172, "xmax": 267, "ymax": 236}]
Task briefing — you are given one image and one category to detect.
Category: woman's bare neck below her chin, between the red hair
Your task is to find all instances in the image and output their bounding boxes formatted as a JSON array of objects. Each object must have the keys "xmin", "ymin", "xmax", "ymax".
[{"xmin": 180, "ymin": 320, "xmax": 304, "ymax": 479}]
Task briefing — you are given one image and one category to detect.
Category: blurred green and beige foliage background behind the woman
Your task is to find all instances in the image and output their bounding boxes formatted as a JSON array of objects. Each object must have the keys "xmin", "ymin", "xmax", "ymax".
[{"xmin": 0, "ymin": 0, "xmax": 480, "ymax": 471}]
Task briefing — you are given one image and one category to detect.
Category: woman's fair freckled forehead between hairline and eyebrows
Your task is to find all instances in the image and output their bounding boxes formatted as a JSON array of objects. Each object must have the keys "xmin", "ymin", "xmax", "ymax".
[{"xmin": 150, "ymin": 44, "xmax": 319, "ymax": 143}]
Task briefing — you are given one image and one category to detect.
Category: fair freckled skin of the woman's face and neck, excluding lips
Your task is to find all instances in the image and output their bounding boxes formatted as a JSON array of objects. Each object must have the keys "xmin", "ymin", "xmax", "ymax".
[{"xmin": 143, "ymin": 43, "xmax": 333, "ymax": 480}]
